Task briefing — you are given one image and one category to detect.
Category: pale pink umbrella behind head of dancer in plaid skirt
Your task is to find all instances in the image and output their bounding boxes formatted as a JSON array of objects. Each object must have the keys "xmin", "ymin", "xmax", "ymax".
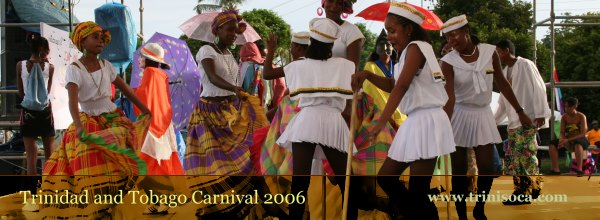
[{"xmin": 179, "ymin": 12, "xmax": 261, "ymax": 45}]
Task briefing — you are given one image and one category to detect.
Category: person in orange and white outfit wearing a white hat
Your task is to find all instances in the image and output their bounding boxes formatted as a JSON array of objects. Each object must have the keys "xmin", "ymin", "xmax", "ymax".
[{"xmin": 134, "ymin": 43, "xmax": 187, "ymax": 214}]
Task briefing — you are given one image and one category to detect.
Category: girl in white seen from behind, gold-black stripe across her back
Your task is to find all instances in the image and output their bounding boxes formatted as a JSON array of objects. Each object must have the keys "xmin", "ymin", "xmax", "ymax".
[{"xmin": 277, "ymin": 18, "xmax": 358, "ymax": 219}]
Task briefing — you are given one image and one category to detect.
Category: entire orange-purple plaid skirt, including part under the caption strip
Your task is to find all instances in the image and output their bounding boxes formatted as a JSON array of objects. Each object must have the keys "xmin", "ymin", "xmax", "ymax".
[{"xmin": 184, "ymin": 93, "xmax": 268, "ymax": 219}]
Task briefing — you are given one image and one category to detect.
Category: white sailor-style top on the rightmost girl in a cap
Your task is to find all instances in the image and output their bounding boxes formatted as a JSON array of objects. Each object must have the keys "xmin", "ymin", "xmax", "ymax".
[{"xmin": 442, "ymin": 43, "xmax": 496, "ymax": 107}]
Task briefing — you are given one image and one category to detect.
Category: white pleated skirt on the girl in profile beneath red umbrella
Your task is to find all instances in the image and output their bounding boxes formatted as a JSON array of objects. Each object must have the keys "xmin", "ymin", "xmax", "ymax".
[{"xmin": 388, "ymin": 108, "xmax": 456, "ymax": 162}]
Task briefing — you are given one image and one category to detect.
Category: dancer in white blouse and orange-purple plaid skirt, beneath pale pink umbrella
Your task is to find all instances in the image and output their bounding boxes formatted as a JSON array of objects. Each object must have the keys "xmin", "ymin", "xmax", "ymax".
[{"xmin": 184, "ymin": 11, "xmax": 267, "ymax": 219}]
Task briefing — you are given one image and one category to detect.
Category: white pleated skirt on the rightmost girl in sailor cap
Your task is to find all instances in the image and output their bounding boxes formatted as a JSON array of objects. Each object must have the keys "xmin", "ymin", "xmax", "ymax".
[{"xmin": 452, "ymin": 104, "xmax": 502, "ymax": 148}]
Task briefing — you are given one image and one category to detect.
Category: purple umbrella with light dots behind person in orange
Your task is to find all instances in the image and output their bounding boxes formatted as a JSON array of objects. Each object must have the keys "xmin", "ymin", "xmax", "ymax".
[{"xmin": 131, "ymin": 33, "xmax": 200, "ymax": 131}]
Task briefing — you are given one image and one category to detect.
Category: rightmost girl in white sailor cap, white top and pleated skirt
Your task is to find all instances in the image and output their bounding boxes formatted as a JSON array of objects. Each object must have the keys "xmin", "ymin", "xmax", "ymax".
[{"xmin": 442, "ymin": 15, "xmax": 531, "ymax": 219}]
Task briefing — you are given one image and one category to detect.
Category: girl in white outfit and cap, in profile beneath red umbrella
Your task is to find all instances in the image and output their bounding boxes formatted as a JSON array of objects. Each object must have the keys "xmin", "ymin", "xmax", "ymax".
[{"xmin": 353, "ymin": 3, "xmax": 455, "ymax": 219}]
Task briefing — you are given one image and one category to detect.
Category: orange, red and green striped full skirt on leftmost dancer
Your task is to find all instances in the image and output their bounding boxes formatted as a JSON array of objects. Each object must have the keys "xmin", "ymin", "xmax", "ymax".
[{"xmin": 40, "ymin": 111, "xmax": 150, "ymax": 219}]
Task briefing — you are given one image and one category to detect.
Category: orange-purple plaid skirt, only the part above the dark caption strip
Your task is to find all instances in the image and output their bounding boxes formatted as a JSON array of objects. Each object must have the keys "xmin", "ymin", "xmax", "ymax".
[{"xmin": 184, "ymin": 93, "xmax": 268, "ymax": 175}]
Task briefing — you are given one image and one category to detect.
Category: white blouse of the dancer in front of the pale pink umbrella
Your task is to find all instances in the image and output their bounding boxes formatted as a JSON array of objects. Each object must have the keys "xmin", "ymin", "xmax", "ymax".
[{"xmin": 196, "ymin": 45, "xmax": 242, "ymax": 97}]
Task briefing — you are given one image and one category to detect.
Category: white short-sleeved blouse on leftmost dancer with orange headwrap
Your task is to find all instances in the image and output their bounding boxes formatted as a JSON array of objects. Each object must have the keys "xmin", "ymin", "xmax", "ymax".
[{"xmin": 65, "ymin": 60, "xmax": 117, "ymax": 116}]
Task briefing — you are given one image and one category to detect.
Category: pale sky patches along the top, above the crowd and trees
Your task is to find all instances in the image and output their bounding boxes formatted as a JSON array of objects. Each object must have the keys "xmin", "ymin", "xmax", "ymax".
[{"xmin": 73, "ymin": 0, "xmax": 600, "ymax": 39}]
